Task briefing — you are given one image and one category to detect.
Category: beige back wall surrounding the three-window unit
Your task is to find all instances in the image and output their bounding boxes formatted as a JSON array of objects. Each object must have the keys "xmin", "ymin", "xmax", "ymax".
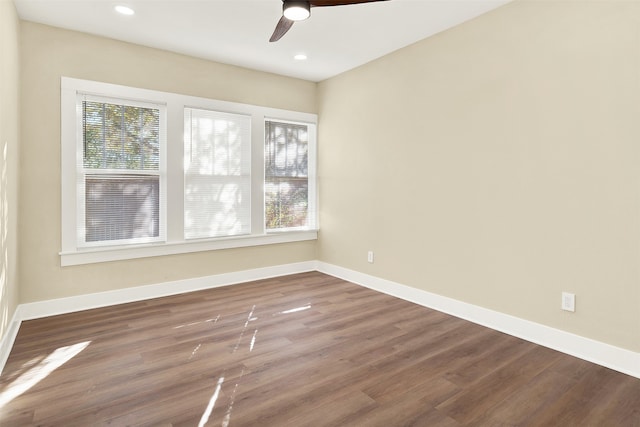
[{"xmin": 20, "ymin": 22, "xmax": 316, "ymax": 303}]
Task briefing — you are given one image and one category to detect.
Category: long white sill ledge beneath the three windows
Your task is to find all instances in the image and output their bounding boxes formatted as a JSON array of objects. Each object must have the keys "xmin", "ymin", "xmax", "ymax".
[{"xmin": 60, "ymin": 230, "xmax": 318, "ymax": 267}]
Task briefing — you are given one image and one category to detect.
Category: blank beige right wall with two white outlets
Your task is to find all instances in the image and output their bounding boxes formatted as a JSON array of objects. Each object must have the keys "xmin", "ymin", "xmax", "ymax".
[{"xmin": 319, "ymin": 1, "xmax": 640, "ymax": 352}]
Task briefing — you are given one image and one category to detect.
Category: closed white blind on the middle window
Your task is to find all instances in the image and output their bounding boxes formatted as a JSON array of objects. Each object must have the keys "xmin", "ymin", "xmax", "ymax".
[{"xmin": 184, "ymin": 108, "xmax": 251, "ymax": 239}]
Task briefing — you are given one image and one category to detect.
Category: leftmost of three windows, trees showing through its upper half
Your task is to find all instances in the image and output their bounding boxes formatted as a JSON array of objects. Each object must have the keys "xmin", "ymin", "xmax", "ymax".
[{"xmin": 77, "ymin": 95, "xmax": 165, "ymax": 247}]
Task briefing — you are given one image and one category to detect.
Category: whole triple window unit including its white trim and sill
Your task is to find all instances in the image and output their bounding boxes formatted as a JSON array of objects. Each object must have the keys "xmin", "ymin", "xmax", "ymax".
[{"xmin": 60, "ymin": 77, "xmax": 317, "ymax": 266}]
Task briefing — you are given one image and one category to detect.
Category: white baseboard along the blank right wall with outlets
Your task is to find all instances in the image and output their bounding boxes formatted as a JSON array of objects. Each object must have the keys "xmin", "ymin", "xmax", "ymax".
[{"xmin": 317, "ymin": 262, "xmax": 640, "ymax": 378}]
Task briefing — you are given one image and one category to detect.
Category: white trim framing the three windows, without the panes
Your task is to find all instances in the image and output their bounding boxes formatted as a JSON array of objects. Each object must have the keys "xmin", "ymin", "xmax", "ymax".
[{"xmin": 60, "ymin": 77, "xmax": 318, "ymax": 266}]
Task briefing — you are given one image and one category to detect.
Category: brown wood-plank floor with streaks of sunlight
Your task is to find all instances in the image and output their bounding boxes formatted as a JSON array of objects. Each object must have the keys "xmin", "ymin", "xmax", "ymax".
[{"xmin": 0, "ymin": 273, "xmax": 640, "ymax": 427}]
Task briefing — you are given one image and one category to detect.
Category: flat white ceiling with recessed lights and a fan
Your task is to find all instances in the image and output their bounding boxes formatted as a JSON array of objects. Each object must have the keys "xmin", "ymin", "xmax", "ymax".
[{"xmin": 14, "ymin": 0, "xmax": 510, "ymax": 82}]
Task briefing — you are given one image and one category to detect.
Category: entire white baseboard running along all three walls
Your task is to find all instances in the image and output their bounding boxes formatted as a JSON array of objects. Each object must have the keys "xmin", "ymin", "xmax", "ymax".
[{"xmin": 0, "ymin": 261, "xmax": 640, "ymax": 378}]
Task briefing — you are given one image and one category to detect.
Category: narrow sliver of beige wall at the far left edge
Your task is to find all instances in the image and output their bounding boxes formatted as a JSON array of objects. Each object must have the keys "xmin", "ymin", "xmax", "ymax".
[{"xmin": 0, "ymin": 0, "xmax": 20, "ymax": 338}]
